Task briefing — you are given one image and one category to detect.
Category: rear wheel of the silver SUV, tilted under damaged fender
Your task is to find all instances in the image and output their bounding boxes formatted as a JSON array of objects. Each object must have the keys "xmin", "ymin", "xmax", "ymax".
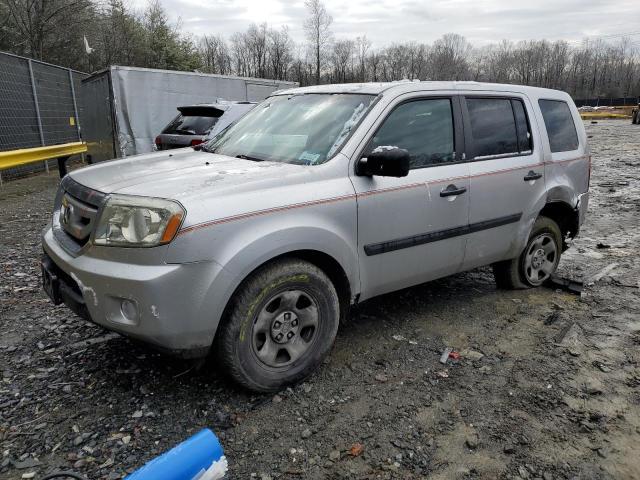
[{"xmin": 493, "ymin": 215, "xmax": 562, "ymax": 290}]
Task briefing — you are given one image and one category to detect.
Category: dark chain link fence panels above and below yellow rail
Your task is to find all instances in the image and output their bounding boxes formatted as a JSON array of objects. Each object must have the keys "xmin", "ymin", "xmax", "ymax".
[{"xmin": 0, "ymin": 52, "xmax": 89, "ymax": 178}]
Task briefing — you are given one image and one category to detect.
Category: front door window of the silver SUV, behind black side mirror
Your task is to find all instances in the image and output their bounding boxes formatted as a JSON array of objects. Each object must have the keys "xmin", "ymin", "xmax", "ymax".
[{"xmin": 366, "ymin": 98, "xmax": 455, "ymax": 169}]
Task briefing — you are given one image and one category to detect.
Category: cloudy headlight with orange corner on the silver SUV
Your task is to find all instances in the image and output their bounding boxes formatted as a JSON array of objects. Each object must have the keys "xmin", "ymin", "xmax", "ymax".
[{"xmin": 94, "ymin": 195, "xmax": 186, "ymax": 247}]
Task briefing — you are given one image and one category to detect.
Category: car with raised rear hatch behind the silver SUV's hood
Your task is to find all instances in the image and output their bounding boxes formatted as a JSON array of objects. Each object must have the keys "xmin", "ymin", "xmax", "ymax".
[{"xmin": 155, "ymin": 101, "xmax": 256, "ymax": 150}]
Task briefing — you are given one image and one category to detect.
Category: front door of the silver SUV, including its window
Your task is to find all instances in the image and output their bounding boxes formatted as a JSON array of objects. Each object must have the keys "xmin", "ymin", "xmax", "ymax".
[{"xmin": 352, "ymin": 96, "xmax": 469, "ymax": 299}]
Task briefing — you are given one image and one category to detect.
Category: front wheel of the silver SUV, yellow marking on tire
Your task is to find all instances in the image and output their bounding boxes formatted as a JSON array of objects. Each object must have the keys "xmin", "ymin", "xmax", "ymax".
[{"xmin": 214, "ymin": 259, "xmax": 340, "ymax": 392}]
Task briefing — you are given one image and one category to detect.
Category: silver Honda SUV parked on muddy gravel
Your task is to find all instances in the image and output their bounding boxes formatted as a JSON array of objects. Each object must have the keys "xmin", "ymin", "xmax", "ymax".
[{"xmin": 42, "ymin": 82, "xmax": 590, "ymax": 391}]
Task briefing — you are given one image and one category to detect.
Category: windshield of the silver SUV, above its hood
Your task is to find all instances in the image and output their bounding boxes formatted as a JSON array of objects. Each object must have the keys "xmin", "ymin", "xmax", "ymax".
[{"xmin": 204, "ymin": 94, "xmax": 375, "ymax": 165}]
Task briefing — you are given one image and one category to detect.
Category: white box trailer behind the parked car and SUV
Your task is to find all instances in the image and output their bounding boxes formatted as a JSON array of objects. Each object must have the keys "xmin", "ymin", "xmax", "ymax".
[{"xmin": 80, "ymin": 66, "xmax": 298, "ymax": 163}]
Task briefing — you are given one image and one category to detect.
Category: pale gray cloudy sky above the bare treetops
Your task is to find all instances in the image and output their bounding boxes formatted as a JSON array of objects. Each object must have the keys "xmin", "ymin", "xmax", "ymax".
[{"xmin": 131, "ymin": 0, "xmax": 640, "ymax": 47}]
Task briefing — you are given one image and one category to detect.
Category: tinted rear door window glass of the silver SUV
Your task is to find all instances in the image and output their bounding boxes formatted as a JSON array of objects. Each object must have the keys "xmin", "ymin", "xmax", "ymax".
[{"xmin": 466, "ymin": 98, "xmax": 519, "ymax": 158}]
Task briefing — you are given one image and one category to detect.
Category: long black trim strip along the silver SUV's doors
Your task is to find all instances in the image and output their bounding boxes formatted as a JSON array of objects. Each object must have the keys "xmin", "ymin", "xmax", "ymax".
[{"xmin": 364, "ymin": 213, "xmax": 522, "ymax": 257}]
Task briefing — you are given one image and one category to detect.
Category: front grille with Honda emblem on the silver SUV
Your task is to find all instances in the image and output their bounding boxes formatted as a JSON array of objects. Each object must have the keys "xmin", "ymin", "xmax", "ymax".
[{"xmin": 53, "ymin": 176, "xmax": 106, "ymax": 255}]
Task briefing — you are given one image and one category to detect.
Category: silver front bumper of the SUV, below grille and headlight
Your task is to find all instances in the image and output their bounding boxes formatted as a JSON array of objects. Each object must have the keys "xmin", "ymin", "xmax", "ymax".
[{"xmin": 42, "ymin": 228, "xmax": 223, "ymax": 358}]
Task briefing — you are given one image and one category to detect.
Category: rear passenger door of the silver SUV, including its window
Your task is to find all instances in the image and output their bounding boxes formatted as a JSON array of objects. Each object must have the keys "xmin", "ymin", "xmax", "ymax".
[{"xmin": 462, "ymin": 92, "xmax": 545, "ymax": 269}]
